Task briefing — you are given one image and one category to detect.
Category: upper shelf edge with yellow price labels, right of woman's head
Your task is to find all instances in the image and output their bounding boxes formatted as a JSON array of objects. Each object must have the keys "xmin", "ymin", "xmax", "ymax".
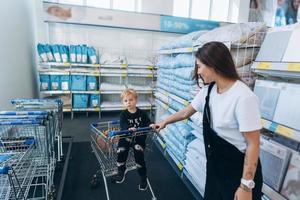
[{"xmin": 251, "ymin": 62, "xmax": 300, "ymax": 78}]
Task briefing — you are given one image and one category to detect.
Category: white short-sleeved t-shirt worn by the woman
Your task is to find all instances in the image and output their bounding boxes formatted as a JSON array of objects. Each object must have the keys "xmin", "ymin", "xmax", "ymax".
[{"xmin": 191, "ymin": 81, "xmax": 262, "ymax": 152}]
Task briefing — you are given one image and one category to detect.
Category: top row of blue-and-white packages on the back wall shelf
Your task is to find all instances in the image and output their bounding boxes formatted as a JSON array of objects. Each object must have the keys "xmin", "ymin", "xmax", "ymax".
[{"xmin": 37, "ymin": 43, "xmax": 98, "ymax": 64}]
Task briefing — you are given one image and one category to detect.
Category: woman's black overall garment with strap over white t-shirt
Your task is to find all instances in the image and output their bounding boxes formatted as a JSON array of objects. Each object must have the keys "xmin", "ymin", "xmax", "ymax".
[{"xmin": 203, "ymin": 83, "xmax": 262, "ymax": 200}]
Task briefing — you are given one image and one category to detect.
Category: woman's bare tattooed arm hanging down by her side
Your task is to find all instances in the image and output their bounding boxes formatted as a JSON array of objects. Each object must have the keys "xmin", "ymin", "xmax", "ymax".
[{"xmin": 234, "ymin": 130, "xmax": 260, "ymax": 200}]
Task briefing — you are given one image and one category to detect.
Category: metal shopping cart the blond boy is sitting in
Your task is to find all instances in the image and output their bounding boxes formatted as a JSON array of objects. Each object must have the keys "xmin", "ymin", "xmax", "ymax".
[{"xmin": 91, "ymin": 121, "xmax": 157, "ymax": 200}]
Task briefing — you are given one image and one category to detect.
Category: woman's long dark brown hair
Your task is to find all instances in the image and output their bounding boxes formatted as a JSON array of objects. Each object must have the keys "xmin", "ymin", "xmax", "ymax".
[{"xmin": 193, "ymin": 42, "xmax": 240, "ymax": 86}]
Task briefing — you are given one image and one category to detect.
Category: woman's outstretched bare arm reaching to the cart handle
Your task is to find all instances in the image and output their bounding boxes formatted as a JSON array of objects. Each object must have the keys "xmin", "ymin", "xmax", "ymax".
[{"xmin": 150, "ymin": 105, "xmax": 196, "ymax": 131}]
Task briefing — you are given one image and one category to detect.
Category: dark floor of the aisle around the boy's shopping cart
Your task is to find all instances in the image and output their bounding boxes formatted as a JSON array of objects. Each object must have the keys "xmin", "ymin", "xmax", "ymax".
[{"xmin": 62, "ymin": 113, "xmax": 194, "ymax": 200}]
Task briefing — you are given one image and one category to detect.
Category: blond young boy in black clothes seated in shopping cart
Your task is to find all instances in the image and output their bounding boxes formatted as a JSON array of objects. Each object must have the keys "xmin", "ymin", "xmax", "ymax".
[{"xmin": 116, "ymin": 89, "xmax": 150, "ymax": 190}]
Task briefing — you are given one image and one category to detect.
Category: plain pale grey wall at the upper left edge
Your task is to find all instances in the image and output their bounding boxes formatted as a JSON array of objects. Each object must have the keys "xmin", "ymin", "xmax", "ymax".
[{"xmin": 0, "ymin": 0, "xmax": 37, "ymax": 110}]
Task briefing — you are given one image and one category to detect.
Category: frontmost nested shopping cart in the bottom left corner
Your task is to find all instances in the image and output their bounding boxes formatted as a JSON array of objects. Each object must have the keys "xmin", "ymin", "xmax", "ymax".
[{"xmin": 0, "ymin": 137, "xmax": 36, "ymax": 199}]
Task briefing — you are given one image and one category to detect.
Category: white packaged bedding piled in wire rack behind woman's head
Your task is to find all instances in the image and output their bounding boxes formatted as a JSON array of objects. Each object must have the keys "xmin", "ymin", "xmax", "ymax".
[{"xmin": 194, "ymin": 22, "xmax": 267, "ymax": 86}]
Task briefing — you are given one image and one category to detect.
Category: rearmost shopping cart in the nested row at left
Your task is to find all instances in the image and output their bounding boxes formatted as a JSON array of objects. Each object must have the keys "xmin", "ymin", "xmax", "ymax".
[{"xmin": 11, "ymin": 99, "xmax": 63, "ymax": 162}]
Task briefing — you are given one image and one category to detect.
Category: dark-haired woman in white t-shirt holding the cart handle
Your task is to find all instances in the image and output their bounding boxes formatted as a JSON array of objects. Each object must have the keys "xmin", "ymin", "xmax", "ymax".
[{"xmin": 152, "ymin": 42, "xmax": 262, "ymax": 200}]
